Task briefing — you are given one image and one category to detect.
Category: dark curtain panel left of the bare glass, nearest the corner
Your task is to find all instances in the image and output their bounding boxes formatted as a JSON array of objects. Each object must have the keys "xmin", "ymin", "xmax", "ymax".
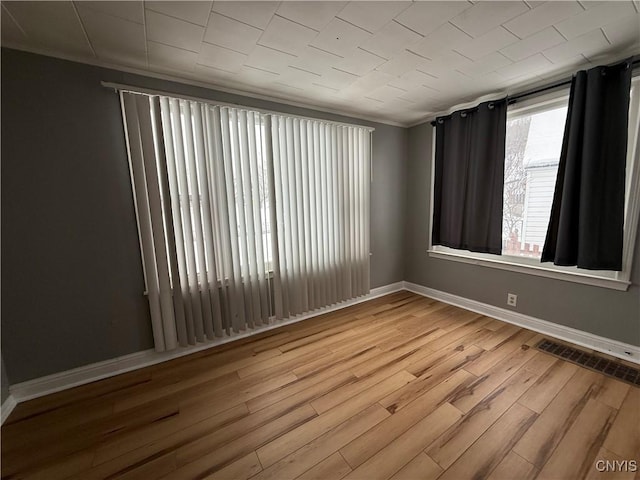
[{"xmin": 432, "ymin": 99, "xmax": 507, "ymax": 255}]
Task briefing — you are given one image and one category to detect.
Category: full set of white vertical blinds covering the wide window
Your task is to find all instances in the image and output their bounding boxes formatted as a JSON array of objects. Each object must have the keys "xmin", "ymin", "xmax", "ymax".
[{"xmin": 120, "ymin": 92, "xmax": 371, "ymax": 351}]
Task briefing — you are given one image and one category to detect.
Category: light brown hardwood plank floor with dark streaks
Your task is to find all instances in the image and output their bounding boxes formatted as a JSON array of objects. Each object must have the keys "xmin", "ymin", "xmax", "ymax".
[{"xmin": 2, "ymin": 292, "xmax": 640, "ymax": 480}]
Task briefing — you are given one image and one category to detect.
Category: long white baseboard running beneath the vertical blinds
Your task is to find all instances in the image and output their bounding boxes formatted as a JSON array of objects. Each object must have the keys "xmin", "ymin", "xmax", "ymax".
[{"xmin": 7, "ymin": 282, "xmax": 404, "ymax": 404}]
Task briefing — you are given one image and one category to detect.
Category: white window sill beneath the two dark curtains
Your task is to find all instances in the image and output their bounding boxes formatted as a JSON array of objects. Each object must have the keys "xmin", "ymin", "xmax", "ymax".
[{"xmin": 427, "ymin": 250, "xmax": 631, "ymax": 291}]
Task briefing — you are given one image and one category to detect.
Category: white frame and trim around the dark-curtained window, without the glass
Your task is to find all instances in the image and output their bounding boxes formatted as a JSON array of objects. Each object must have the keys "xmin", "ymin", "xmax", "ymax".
[{"xmin": 427, "ymin": 77, "xmax": 640, "ymax": 291}]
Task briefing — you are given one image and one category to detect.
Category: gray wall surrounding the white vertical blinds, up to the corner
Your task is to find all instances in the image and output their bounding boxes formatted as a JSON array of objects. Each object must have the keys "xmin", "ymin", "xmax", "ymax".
[{"xmin": 2, "ymin": 49, "xmax": 407, "ymax": 383}]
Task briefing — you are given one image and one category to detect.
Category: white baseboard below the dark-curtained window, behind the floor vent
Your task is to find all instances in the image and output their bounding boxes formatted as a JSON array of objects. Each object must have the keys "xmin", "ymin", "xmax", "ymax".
[{"xmin": 404, "ymin": 282, "xmax": 640, "ymax": 363}]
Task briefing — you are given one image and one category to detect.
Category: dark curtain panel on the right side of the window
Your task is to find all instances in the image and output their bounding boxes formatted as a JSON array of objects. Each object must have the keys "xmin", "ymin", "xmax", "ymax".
[{"xmin": 542, "ymin": 61, "xmax": 631, "ymax": 270}]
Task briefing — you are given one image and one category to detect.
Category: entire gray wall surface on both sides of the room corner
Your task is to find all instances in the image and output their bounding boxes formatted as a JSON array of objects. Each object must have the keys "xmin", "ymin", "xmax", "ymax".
[{"xmin": 1, "ymin": 45, "xmax": 640, "ymax": 388}]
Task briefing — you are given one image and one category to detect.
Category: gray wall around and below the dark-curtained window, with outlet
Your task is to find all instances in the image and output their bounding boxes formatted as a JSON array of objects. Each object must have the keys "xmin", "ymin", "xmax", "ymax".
[{"xmin": 404, "ymin": 120, "xmax": 640, "ymax": 345}]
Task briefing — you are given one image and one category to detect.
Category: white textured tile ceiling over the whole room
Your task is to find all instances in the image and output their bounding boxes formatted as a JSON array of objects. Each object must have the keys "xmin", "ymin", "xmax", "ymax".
[{"xmin": 2, "ymin": 0, "xmax": 640, "ymax": 125}]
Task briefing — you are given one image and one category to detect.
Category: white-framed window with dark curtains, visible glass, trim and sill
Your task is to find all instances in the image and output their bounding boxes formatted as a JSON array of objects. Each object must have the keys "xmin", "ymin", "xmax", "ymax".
[{"xmin": 429, "ymin": 76, "xmax": 640, "ymax": 290}]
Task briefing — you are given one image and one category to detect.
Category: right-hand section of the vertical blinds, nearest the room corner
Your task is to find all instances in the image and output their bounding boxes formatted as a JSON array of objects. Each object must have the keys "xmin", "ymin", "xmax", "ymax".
[{"xmin": 270, "ymin": 115, "xmax": 370, "ymax": 318}]
